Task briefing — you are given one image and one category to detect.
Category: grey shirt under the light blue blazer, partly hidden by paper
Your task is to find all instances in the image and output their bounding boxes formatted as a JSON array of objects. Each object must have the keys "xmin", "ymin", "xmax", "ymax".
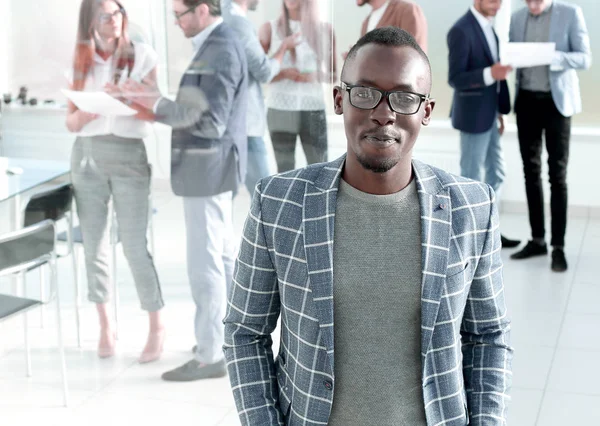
[{"xmin": 519, "ymin": 5, "xmax": 552, "ymax": 92}]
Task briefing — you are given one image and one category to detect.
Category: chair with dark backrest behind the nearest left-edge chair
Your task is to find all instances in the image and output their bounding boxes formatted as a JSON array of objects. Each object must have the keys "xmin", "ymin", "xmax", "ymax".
[{"xmin": 23, "ymin": 184, "xmax": 81, "ymax": 347}]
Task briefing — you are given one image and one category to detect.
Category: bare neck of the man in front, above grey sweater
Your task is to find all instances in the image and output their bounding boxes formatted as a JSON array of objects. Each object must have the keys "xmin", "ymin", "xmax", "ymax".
[{"xmin": 342, "ymin": 155, "xmax": 413, "ymax": 195}]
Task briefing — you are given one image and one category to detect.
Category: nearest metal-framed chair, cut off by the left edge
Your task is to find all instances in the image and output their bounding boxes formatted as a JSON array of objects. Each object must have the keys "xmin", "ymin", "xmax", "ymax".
[{"xmin": 0, "ymin": 220, "xmax": 69, "ymax": 407}]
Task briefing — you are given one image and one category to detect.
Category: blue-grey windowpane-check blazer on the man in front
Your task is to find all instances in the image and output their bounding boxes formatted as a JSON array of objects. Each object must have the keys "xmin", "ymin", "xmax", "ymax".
[{"xmin": 224, "ymin": 156, "xmax": 512, "ymax": 426}]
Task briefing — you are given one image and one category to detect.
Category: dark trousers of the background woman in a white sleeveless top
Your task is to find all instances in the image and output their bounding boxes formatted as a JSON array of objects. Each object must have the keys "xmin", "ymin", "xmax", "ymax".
[{"xmin": 267, "ymin": 108, "xmax": 327, "ymax": 173}]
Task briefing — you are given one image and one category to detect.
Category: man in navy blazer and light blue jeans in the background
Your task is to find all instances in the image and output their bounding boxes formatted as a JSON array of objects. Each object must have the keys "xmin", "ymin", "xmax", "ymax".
[{"xmin": 448, "ymin": 0, "xmax": 519, "ymax": 247}]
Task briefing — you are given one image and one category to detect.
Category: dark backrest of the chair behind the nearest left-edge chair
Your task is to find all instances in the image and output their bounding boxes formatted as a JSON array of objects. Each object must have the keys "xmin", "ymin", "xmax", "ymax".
[{"xmin": 23, "ymin": 184, "xmax": 73, "ymax": 226}]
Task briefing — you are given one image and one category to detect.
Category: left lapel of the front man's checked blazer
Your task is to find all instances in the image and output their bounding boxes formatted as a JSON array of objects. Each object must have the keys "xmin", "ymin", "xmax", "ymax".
[{"xmin": 302, "ymin": 155, "xmax": 346, "ymax": 355}]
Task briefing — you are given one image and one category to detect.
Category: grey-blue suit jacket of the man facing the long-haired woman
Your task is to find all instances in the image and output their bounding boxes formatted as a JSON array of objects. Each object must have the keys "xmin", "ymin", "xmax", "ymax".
[{"xmin": 156, "ymin": 23, "xmax": 248, "ymax": 197}]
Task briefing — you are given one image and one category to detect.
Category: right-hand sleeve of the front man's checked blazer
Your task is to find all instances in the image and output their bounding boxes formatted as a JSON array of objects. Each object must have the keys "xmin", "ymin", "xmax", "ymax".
[{"xmin": 461, "ymin": 187, "xmax": 513, "ymax": 426}]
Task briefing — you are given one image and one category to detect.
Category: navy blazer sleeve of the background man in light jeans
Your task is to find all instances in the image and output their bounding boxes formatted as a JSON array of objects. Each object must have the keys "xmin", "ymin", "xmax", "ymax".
[{"xmin": 447, "ymin": 27, "xmax": 485, "ymax": 90}]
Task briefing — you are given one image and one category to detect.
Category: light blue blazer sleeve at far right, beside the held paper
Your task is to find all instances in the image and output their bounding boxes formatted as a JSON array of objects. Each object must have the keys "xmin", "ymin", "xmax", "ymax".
[{"xmin": 550, "ymin": 7, "xmax": 592, "ymax": 71}]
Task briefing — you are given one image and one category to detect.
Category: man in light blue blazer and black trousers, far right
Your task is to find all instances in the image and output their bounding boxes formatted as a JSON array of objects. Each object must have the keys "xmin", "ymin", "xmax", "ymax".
[{"xmin": 510, "ymin": 0, "xmax": 592, "ymax": 272}]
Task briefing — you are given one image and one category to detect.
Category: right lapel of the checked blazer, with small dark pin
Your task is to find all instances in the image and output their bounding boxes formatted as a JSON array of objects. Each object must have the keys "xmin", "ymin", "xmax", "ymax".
[{"xmin": 413, "ymin": 160, "xmax": 452, "ymax": 362}]
